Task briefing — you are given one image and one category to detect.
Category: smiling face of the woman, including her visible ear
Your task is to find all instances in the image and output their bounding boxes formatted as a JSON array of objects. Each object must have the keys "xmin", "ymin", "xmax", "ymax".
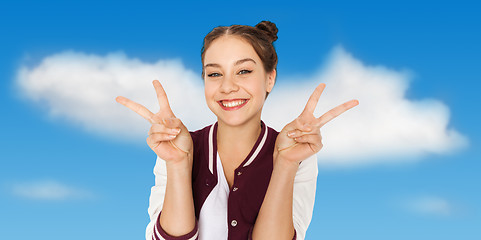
[{"xmin": 204, "ymin": 36, "xmax": 276, "ymax": 126}]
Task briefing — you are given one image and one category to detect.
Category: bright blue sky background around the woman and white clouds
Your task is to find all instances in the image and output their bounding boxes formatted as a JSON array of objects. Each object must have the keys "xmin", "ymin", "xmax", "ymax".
[{"xmin": 0, "ymin": 1, "xmax": 481, "ymax": 240}]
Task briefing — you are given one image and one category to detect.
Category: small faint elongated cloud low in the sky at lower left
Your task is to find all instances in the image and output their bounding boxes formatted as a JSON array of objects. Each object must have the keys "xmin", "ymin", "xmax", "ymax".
[{"xmin": 11, "ymin": 180, "xmax": 92, "ymax": 200}]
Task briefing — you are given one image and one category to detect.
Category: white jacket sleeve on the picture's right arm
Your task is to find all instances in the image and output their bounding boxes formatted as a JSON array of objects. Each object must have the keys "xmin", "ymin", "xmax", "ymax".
[{"xmin": 292, "ymin": 154, "xmax": 318, "ymax": 240}]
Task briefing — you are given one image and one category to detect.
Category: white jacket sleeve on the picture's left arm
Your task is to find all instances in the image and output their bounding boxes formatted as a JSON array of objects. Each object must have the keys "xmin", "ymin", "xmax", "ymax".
[{"xmin": 145, "ymin": 157, "xmax": 167, "ymax": 240}]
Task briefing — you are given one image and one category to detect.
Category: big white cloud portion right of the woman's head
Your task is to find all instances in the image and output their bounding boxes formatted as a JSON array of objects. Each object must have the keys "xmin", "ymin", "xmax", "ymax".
[{"xmin": 266, "ymin": 47, "xmax": 467, "ymax": 166}]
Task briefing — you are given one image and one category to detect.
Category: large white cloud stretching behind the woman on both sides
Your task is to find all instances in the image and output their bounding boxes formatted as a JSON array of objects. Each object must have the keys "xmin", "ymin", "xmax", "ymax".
[{"xmin": 17, "ymin": 48, "xmax": 467, "ymax": 166}]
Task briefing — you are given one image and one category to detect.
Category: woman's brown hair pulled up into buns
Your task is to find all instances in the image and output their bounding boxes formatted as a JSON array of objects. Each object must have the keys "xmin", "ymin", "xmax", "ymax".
[{"xmin": 201, "ymin": 21, "xmax": 277, "ymax": 78}]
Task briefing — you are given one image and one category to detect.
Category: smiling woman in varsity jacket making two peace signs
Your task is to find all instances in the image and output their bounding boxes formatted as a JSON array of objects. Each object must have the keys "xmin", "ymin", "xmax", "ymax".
[{"xmin": 116, "ymin": 21, "xmax": 358, "ymax": 240}]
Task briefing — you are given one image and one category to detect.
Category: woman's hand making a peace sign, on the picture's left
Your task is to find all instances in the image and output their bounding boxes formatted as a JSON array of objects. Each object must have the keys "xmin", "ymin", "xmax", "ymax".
[{"xmin": 115, "ymin": 80, "xmax": 193, "ymax": 162}]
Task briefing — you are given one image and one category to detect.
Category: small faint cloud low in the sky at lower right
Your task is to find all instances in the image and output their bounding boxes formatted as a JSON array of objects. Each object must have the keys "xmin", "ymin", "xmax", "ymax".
[{"xmin": 406, "ymin": 196, "xmax": 454, "ymax": 216}]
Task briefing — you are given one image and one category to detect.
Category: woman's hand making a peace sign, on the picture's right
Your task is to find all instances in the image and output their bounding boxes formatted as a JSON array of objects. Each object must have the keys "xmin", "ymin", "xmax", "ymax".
[{"xmin": 274, "ymin": 83, "xmax": 359, "ymax": 163}]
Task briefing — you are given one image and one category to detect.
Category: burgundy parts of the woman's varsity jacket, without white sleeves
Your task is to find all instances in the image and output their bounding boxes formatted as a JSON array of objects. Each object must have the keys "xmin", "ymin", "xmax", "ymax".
[{"xmin": 149, "ymin": 122, "xmax": 317, "ymax": 240}]
